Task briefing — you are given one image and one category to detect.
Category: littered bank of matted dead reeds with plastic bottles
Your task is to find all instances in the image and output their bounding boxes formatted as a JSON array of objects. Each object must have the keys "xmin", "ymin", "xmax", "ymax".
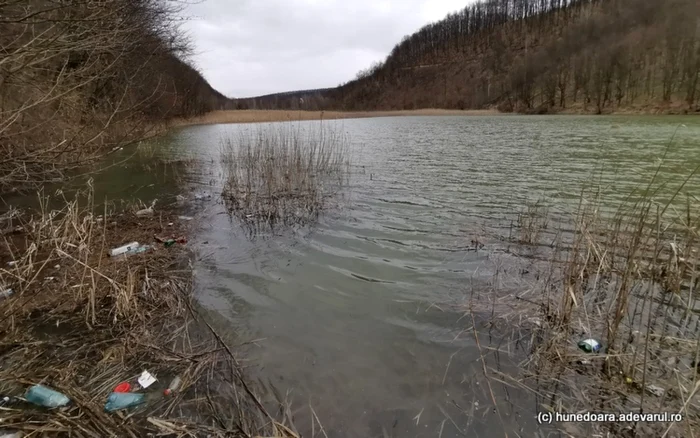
[{"xmin": 0, "ymin": 189, "xmax": 298, "ymax": 438}]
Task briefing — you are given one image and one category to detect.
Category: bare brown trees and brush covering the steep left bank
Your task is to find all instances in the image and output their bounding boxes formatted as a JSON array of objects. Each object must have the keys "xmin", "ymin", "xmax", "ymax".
[{"xmin": 0, "ymin": 0, "xmax": 228, "ymax": 191}]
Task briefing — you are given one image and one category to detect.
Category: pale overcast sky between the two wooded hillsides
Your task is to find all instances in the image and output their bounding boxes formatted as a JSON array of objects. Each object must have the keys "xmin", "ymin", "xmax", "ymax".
[{"xmin": 180, "ymin": 0, "xmax": 470, "ymax": 97}]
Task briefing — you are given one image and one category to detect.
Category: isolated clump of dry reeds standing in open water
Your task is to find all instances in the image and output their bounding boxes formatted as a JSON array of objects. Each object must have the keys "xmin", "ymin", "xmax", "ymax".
[{"xmin": 221, "ymin": 122, "xmax": 350, "ymax": 228}]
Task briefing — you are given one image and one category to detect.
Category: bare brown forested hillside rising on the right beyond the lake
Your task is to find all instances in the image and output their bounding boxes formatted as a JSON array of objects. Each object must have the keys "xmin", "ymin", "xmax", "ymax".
[{"xmin": 239, "ymin": 0, "xmax": 700, "ymax": 113}]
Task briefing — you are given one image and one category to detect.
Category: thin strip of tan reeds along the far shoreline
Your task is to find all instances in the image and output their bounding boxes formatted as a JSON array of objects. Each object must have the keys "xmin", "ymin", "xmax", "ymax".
[{"xmin": 170, "ymin": 109, "xmax": 507, "ymax": 127}]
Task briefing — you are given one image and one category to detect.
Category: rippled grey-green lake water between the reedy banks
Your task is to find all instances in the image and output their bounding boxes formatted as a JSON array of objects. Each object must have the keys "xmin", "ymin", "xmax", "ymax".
[{"xmin": 8, "ymin": 116, "xmax": 700, "ymax": 437}]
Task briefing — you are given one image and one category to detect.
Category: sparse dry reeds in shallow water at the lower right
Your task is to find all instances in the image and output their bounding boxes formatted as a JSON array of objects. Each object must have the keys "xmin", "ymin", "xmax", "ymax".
[{"xmin": 470, "ymin": 163, "xmax": 700, "ymax": 437}]
